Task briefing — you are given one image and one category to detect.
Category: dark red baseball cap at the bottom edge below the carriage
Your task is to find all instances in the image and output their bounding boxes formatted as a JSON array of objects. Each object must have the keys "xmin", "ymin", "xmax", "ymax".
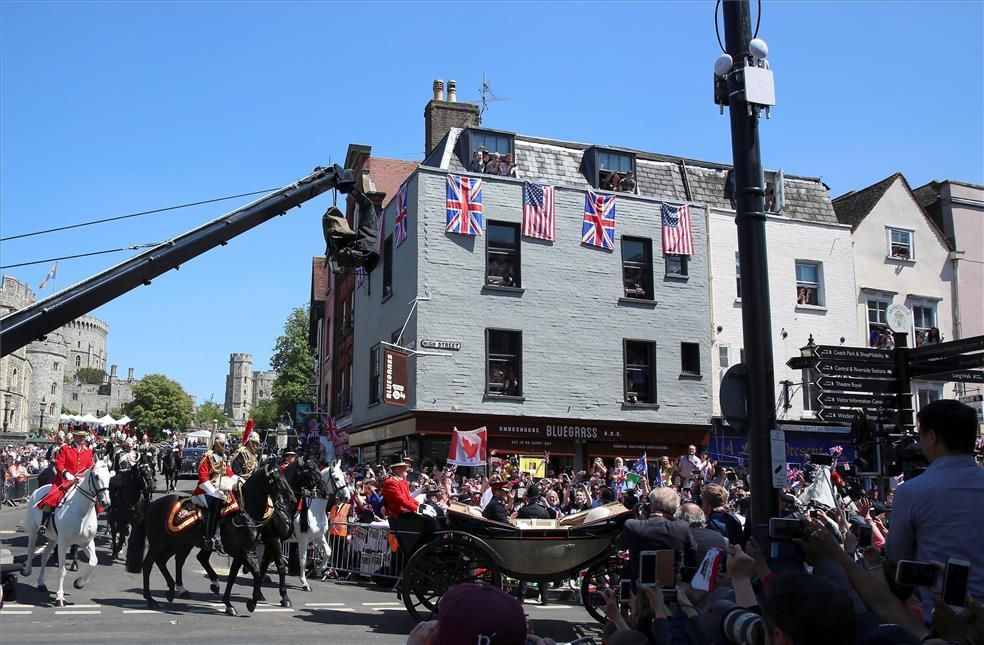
[{"xmin": 431, "ymin": 582, "xmax": 526, "ymax": 645}]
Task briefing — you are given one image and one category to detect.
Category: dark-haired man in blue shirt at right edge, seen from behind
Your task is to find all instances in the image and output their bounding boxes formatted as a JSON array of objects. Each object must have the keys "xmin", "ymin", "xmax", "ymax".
[{"xmin": 885, "ymin": 400, "xmax": 984, "ymax": 615}]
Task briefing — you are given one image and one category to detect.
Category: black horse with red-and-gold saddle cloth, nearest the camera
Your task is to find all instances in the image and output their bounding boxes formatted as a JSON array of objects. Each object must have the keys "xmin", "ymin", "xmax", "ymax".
[{"xmin": 126, "ymin": 465, "xmax": 297, "ymax": 616}]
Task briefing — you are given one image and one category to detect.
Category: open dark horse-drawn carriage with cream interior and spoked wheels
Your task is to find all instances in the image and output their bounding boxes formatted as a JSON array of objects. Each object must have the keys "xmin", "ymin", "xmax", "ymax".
[{"xmin": 391, "ymin": 502, "xmax": 632, "ymax": 621}]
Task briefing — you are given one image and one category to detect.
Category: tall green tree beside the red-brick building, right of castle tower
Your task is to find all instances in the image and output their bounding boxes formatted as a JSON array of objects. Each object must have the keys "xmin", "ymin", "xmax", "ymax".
[{"xmin": 270, "ymin": 307, "xmax": 314, "ymax": 418}]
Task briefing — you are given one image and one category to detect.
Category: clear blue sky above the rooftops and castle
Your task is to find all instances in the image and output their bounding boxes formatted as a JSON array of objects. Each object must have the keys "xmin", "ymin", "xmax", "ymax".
[{"xmin": 0, "ymin": 0, "xmax": 984, "ymax": 402}]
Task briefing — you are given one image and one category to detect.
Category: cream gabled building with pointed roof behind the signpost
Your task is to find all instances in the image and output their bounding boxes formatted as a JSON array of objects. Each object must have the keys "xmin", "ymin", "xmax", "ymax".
[{"xmin": 833, "ymin": 173, "xmax": 955, "ymax": 409}]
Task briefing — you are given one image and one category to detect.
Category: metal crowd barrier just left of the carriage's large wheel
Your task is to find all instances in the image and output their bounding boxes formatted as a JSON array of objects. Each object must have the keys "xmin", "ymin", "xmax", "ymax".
[{"xmin": 289, "ymin": 520, "xmax": 406, "ymax": 585}]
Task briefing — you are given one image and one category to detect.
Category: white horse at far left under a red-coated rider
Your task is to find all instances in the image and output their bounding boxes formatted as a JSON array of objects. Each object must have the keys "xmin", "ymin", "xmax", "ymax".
[{"xmin": 21, "ymin": 459, "xmax": 113, "ymax": 607}]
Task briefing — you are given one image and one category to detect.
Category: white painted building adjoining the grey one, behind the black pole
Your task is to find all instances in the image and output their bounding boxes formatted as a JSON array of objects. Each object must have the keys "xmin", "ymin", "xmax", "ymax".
[{"xmin": 704, "ymin": 174, "xmax": 859, "ymax": 420}]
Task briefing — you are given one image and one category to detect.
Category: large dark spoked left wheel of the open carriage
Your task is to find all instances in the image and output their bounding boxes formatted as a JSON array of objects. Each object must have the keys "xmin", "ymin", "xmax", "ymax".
[{"xmin": 400, "ymin": 534, "xmax": 502, "ymax": 622}]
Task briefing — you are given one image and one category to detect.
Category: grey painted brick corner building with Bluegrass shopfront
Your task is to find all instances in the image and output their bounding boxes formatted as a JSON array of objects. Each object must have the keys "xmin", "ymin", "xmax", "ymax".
[{"xmin": 350, "ymin": 92, "xmax": 712, "ymax": 465}]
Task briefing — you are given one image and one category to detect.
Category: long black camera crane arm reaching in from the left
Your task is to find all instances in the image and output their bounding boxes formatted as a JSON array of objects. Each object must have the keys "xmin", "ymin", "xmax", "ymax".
[{"xmin": 0, "ymin": 165, "xmax": 354, "ymax": 356}]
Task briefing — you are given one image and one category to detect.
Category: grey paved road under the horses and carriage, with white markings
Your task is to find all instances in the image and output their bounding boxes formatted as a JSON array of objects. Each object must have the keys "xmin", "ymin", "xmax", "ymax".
[{"xmin": 0, "ymin": 472, "xmax": 600, "ymax": 645}]
